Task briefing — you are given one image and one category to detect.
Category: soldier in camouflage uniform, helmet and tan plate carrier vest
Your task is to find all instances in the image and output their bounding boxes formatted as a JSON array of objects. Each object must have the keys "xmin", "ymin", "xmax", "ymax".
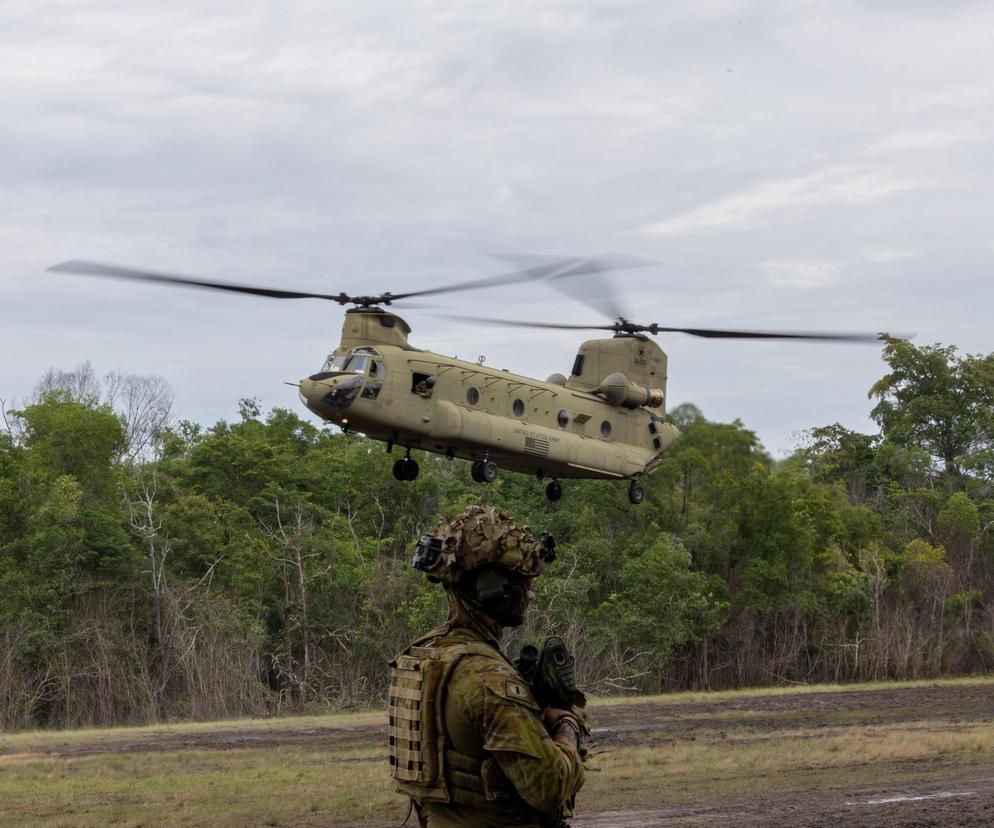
[{"xmin": 390, "ymin": 506, "xmax": 583, "ymax": 828}]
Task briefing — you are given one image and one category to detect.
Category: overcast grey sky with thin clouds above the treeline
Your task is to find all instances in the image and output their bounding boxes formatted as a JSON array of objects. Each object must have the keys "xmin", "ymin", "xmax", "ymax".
[{"xmin": 0, "ymin": 0, "xmax": 994, "ymax": 456}]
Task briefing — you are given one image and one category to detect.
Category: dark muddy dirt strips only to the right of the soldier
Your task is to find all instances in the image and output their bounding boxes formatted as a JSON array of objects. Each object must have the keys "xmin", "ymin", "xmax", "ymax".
[{"xmin": 571, "ymin": 684, "xmax": 994, "ymax": 828}]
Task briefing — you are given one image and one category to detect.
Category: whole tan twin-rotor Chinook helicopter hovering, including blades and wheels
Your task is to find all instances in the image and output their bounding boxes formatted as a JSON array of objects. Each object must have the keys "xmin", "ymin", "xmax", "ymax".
[{"xmin": 49, "ymin": 255, "xmax": 878, "ymax": 503}]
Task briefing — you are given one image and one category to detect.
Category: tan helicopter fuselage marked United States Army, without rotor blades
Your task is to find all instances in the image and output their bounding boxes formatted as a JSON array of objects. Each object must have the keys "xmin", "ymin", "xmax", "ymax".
[{"xmin": 300, "ymin": 308, "xmax": 678, "ymax": 479}]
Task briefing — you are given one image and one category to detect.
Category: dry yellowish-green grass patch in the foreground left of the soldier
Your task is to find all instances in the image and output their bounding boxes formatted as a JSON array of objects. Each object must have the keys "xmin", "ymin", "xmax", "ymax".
[{"xmin": 0, "ymin": 746, "xmax": 404, "ymax": 828}]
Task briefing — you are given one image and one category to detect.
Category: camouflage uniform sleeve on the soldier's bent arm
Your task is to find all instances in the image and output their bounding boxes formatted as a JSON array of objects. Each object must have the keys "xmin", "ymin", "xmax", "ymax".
[{"xmin": 450, "ymin": 657, "xmax": 583, "ymax": 813}]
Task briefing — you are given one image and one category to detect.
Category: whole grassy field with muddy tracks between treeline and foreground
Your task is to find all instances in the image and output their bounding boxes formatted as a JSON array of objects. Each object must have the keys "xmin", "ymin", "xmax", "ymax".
[{"xmin": 0, "ymin": 678, "xmax": 994, "ymax": 828}]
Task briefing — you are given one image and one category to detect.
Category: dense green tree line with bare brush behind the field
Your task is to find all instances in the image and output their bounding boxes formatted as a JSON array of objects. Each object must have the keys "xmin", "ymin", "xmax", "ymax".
[{"xmin": 0, "ymin": 340, "xmax": 994, "ymax": 728}]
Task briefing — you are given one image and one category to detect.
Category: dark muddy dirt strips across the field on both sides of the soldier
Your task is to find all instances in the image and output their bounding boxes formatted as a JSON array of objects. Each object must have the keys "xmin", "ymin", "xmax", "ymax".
[{"xmin": 0, "ymin": 683, "xmax": 994, "ymax": 828}]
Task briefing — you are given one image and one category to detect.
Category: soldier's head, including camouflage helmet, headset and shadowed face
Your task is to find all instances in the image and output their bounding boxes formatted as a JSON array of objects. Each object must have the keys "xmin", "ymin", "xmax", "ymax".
[{"xmin": 406, "ymin": 506, "xmax": 556, "ymax": 627}]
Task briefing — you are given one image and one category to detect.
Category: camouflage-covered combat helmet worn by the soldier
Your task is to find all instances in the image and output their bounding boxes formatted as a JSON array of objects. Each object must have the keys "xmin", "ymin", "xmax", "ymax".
[{"xmin": 413, "ymin": 506, "xmax": 556, "ymax": 583}]
